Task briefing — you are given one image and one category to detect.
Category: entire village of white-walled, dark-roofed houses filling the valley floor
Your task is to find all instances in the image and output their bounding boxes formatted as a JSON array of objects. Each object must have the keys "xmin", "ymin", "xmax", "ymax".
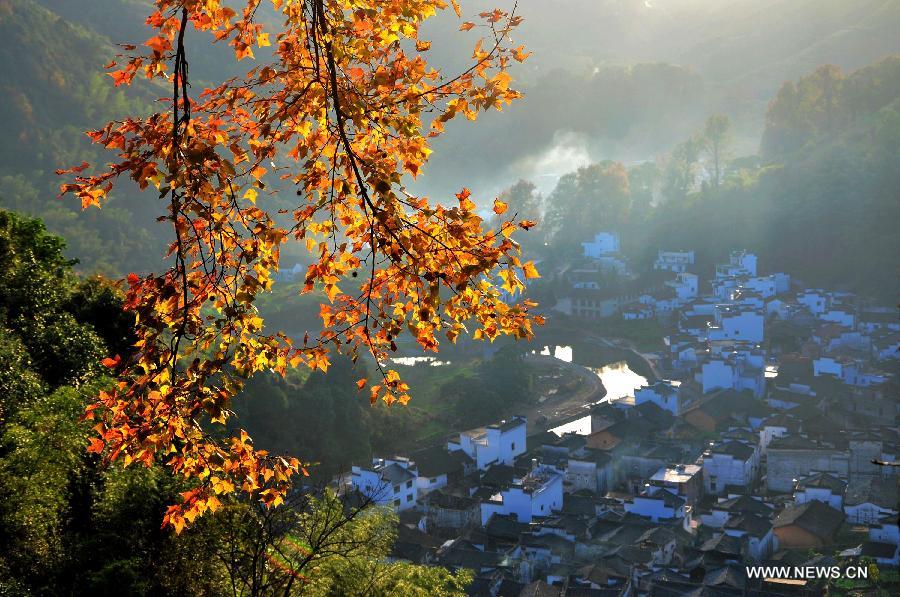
[{"xmin": 343, "ymin": 233, "xmax": 900, "ymax": 596}]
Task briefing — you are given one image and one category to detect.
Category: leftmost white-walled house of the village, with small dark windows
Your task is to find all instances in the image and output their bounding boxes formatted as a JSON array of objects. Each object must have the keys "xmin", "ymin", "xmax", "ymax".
[{"xmin": 350, "ymin": 458, "xmax": 418, "ymax": 512}]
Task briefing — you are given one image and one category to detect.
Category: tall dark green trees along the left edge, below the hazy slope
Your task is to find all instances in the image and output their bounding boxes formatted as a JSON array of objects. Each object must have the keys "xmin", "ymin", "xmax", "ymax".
[{"xmin": 0, "ymin": 211, "xmax": 223, "ymax": 595}]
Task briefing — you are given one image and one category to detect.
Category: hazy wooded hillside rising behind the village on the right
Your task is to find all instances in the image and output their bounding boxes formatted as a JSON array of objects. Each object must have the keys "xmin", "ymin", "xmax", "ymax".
[{"xmin": 508, "ymin": 56, "xmax": 900, "ymax": 301}]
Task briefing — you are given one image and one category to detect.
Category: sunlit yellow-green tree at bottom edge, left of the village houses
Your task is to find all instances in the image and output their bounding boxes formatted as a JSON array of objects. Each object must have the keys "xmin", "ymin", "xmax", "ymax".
[{"xmin": 210, "ymin": 489, "xmax": 472, "ymax": 597}]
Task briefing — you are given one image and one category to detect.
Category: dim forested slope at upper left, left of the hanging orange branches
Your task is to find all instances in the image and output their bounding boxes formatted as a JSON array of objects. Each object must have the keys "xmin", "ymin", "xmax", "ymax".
[{"xmin": 0, "ymin": 0, "xmax": 163, "ymax": 273}]
